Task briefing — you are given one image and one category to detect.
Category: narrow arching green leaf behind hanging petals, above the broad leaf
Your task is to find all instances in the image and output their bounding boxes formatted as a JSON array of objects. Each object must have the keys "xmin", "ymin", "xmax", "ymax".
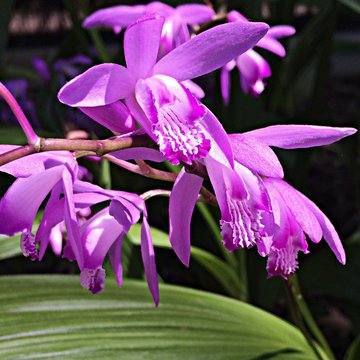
[{"xmin": 128, "ymin": 224, "xmax": 246, "ymax": 299}]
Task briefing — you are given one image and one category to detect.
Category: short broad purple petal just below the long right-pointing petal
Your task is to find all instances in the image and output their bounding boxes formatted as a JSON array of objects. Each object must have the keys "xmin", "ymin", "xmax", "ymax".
[{"xmin": 229, "ymin": 134, "xmax": 284, "ymax": 178}]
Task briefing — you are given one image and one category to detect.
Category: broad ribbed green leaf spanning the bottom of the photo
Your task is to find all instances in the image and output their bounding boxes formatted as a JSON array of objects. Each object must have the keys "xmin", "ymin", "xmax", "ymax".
[{"xmin": 0, "ymin": 276, "xmax": 316, "ymax": 360}]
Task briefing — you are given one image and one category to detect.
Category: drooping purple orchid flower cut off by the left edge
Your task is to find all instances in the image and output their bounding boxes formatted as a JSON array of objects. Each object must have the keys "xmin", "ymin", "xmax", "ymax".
[{"xmin": 0, "ymin": 145, "xmax": 80, "ymax": 260}]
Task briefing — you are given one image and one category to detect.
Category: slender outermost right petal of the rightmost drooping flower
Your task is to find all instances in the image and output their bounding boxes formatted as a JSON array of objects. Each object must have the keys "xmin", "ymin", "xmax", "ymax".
[{"xmin": 299, "ymin": 193, "xmax": 346, "ymax": 265}]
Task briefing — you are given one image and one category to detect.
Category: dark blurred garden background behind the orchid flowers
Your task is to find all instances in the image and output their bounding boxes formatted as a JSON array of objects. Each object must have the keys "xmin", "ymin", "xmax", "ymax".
[{"xmin": 0, "ymin": 0, "xmax": 360, "ymax": 358}]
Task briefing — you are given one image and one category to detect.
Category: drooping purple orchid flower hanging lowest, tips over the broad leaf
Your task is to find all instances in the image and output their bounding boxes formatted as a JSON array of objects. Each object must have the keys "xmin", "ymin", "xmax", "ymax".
[{"xmin": 35, "ymin": 180, "xmax": 159, "ymax": 305}]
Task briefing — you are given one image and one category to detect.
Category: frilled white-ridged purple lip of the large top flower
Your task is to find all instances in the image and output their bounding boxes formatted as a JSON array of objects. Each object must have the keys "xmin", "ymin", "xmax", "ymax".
[{"xmin": 136, "ymin": 75, "xmax": 210, "ymax": 165}]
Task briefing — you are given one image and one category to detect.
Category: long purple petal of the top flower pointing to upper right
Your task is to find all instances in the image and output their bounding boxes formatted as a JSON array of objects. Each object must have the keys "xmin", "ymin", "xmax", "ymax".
[{"xmin": 154, "ymin": 22, "xmax": 269, "ymax": 81}]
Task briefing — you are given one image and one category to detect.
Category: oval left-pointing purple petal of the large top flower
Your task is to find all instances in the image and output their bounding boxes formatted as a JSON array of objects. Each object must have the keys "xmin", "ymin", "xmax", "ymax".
[{"xmin": 58, "ymin": 64, "xmax": 134, "ymax": 107}]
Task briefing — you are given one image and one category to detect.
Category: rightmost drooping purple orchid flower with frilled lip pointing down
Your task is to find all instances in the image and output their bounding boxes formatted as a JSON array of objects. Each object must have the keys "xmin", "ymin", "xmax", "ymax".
[{"xmin": 264, "ymin": 178, "xmax": 346, "ymax": 279}]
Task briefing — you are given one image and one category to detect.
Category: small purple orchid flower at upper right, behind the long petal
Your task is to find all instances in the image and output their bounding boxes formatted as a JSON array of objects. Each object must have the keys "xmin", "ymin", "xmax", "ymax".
[{"xmin": 221, "ymin": 10, "xmax": 295, "ymax": 100}]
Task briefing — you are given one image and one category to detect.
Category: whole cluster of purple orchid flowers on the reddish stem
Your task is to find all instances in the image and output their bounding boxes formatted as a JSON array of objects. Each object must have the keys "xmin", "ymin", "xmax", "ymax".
[{"xmin": 0, "ymin": 2, "xmax": 356, "ymax": 304}]
